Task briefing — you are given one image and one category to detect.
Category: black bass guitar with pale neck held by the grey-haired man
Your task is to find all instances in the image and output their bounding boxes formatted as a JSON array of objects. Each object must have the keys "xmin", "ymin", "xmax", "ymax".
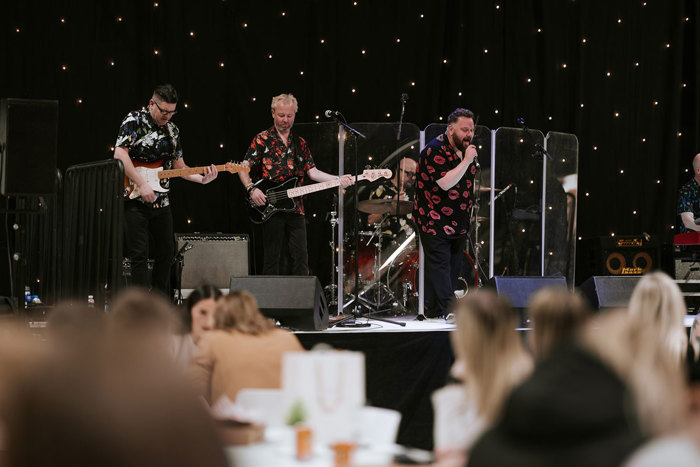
[{"xmin": 248, "ymin": 169, "xmax": 391, "ymax": 224}]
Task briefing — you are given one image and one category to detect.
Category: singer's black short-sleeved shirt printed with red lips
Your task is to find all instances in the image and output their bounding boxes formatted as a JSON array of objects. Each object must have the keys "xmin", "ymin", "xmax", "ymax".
[{"xmin": 413, "ymin": 133, "xmax": 476, "ymax": 238}]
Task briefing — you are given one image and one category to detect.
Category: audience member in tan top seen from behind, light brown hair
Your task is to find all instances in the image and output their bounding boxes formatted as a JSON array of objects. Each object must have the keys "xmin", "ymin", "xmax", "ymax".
[{"xmin": 190, "ymin": 291, "xmax": 303, "ymax": 404}]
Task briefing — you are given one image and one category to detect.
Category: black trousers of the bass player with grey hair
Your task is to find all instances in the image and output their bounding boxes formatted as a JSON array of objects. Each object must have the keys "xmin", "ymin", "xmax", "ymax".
[{"xmin": 262, "ymin": 212, "xmax": 309, "ymax": 276}]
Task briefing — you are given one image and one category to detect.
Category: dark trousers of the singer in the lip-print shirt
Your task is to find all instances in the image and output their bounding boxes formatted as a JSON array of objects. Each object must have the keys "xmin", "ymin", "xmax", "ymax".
[{"xmin": 420, "ymin": 232, "xmax": 467, "ymax": 318}]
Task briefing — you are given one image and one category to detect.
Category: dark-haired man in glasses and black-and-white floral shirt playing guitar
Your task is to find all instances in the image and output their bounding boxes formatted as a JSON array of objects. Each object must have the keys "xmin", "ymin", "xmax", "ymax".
[{"xmin": 114, "ymin": 84, "xmax": 217, "ymax": 296}]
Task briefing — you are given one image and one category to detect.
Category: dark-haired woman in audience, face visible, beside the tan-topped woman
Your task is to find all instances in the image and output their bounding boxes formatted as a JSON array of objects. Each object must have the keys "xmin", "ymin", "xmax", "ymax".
[{"xmin": 173, "ymin": 285, "xmax": 221, "ymax": 366}]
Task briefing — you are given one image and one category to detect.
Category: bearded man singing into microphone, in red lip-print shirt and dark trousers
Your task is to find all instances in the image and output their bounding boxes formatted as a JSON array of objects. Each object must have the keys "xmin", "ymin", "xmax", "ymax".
[{"xmin": 413, "ymin": 108, "xmax": 477, "ymax": 318}]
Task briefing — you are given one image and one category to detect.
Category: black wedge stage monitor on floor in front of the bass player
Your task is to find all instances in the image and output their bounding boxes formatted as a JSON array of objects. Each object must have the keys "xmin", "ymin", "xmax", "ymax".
[{"xmin": 229, "ymin": 276, "xmax": 328, "ymax": 331}]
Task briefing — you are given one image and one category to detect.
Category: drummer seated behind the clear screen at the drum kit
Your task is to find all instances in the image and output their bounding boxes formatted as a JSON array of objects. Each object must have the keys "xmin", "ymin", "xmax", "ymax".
[{"xmin": 367, "ymin": 157, "xmax": 416, "ymax": 239}]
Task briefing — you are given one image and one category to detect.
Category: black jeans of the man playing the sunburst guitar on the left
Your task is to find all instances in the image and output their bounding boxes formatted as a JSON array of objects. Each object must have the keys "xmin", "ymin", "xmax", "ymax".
[{"xmin": 124, "ymin": 200, "xmax": 175, "ymax": 297}]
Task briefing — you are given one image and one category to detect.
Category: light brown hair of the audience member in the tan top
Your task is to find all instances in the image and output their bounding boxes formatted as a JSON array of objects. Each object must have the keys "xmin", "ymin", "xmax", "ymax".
[{"xmin": 214, "ymin": 290, "xmax": 275, "ymax": 336}]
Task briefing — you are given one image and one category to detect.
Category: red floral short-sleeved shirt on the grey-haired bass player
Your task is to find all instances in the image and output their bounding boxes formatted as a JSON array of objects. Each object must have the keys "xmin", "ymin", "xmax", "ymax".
[{"xmin": 244, "ymin": 126, "xmax": 315, "ymax": 214}]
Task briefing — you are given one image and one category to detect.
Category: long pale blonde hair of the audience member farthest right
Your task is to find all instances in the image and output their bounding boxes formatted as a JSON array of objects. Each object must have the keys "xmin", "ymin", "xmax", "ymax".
[{"xmin": 627, "ymin": 272, "xmax": 688, "ymax": 362}]
